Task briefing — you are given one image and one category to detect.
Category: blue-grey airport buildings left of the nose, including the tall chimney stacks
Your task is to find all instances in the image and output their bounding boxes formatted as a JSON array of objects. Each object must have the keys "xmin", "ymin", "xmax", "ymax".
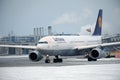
[{"xmin": 0, "ymin": 26, "xmax": 52, "ymax": 55}]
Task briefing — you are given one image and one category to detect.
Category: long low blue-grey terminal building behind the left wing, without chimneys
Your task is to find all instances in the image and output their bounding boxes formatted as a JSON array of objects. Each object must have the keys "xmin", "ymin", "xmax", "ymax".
[{"xmin": 0, "ymin": 36, "xmax": 35, "ymax": 55}]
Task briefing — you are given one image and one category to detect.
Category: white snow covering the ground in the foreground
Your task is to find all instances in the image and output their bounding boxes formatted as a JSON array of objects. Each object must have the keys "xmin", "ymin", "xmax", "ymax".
[{"xmin": 0, "ymin": 64, "xmax": 120, "ymax": 80}]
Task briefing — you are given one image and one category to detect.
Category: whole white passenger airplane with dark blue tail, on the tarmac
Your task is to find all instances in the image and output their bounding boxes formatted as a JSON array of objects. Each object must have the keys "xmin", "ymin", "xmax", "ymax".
[{"xmin": 0, "ymin": 9, "xmax": 120, "ymax": 63}]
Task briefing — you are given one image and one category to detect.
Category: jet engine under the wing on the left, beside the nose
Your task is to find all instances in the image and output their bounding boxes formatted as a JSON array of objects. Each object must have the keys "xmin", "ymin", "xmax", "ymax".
[{"xmin": 29, "ymin": 51, "xmax": 43, "ymax": 61}]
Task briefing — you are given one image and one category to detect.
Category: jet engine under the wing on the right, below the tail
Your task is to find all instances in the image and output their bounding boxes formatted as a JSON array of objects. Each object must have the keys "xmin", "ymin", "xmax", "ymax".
[{"xmin": 89, "ymin": 48, "xmax": 106, "ymax": 59}]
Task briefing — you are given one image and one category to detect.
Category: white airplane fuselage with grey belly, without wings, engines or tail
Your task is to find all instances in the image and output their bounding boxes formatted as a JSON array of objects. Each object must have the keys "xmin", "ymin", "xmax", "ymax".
[{"xmin": 37, "ymin": 36, "xmax": 101, "ymax": 56}]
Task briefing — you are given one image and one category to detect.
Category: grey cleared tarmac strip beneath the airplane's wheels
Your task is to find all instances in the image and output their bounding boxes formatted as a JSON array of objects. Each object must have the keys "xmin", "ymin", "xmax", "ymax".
[{"xmin": 0, "ymin": 55, "xmax": 120, "ymax": 67}]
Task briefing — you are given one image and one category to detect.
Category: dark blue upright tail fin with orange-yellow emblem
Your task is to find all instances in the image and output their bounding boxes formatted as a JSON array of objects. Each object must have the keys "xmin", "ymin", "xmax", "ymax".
[{"xmin": 92, "ymin": 9, "xmax": 102, "ymax": 36}]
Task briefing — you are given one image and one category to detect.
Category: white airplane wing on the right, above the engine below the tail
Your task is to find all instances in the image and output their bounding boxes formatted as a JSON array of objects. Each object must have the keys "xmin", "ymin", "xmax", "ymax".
[{"xmin": 74, "ymin": 42, "xmax": 120, "ymax": 50}]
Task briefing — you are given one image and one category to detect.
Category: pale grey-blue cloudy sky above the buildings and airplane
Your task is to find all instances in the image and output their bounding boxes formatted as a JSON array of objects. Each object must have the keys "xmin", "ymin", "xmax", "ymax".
[{"xmin": 0, "ymin": 0, "xmax": 120, "ymax": 36}]
